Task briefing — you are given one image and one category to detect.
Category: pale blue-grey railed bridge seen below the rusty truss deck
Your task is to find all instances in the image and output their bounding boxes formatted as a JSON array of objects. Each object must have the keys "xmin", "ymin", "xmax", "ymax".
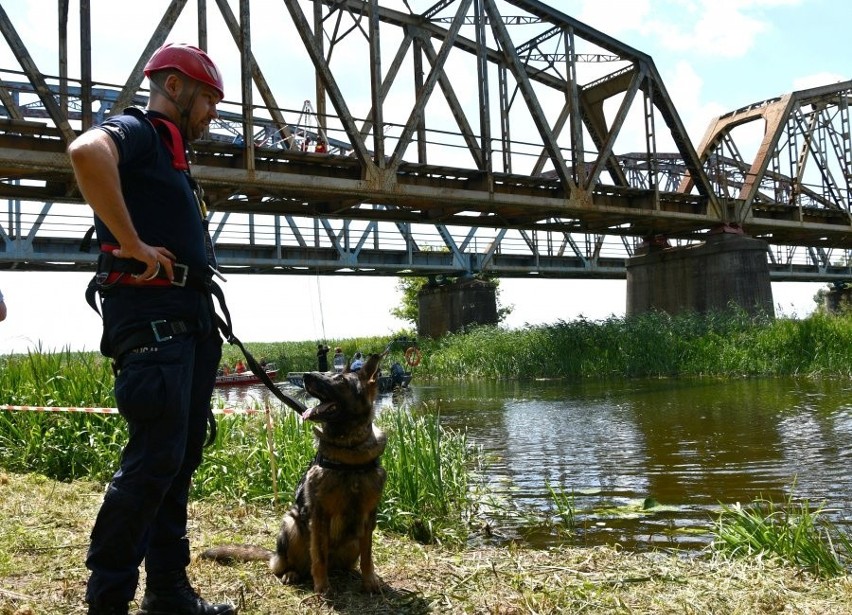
[{"xmin": 0, "ymin": 195, "xmax": 852, "ymax": 281}]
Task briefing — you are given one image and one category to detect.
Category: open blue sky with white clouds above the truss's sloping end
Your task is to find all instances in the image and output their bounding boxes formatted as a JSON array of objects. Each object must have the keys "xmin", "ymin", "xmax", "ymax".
[{"xmin": 576, "ymin": 0, "xmax": 852, "ymax": 143}]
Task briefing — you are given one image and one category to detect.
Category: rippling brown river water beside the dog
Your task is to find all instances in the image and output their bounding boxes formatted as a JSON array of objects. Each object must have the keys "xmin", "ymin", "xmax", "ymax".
[{"xmin": 215, "ymin": 378, "xmax": 852, "ymax": 549}]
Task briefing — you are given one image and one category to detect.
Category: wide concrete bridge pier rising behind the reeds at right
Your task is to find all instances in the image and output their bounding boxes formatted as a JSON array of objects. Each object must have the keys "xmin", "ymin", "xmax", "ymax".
[{"xmin": 627, "ymin": 232, "xmax": 775, "ymax": 317}]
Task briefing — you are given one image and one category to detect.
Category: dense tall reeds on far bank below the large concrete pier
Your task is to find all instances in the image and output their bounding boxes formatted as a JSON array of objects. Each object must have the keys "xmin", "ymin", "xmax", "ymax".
[{"xmin": 417, "ymin": 310, "xmax": 852, "ymax": 380}]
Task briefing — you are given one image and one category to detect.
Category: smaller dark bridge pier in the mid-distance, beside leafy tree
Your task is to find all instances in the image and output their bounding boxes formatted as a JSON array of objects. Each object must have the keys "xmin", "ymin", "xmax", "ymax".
[{"xmin": 417, "ymin": 278, "xmax": 497, "ymax": 338}]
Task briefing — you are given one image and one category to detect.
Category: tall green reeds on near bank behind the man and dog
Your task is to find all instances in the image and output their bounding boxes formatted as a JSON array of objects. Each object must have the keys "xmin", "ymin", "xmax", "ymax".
[{"xmin": 0, "ymin": 400, "xmax": 479, "ymax": 544}]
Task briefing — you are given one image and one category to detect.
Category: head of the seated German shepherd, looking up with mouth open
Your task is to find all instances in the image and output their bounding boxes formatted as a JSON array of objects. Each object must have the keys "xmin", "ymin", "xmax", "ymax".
[{"xmin": 302, "ymin": 354, "xmax": 382, "ymax": 423}]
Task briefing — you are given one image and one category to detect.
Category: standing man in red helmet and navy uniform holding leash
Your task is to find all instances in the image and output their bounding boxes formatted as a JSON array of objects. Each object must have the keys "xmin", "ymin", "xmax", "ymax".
[{"xmin": 68, "ymin": 43, "xmax": 236, "ymax": 615}]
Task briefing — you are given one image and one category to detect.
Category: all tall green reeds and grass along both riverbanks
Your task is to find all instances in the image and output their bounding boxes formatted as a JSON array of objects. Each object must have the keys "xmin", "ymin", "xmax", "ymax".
[{"xmin": 0, "ymin": 311, "xmax": 852, "ymax": 573}]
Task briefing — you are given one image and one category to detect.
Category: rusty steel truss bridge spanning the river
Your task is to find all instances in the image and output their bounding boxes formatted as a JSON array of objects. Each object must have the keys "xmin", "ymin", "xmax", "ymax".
[{"xmin": 0, "ymin": 0, "xmax": 852, "ymax": 281}]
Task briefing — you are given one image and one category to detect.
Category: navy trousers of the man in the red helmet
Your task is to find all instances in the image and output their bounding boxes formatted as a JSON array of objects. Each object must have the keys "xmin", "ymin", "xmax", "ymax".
[{"xmin": 86, "ymin": 288, "xmax": 222, "ymax": 604}]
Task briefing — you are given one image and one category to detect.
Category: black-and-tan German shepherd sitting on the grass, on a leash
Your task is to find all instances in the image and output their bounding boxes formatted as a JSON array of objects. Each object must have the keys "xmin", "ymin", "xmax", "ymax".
[{"xmin": 201, "ymin": 354, "xmax": 387, "ymax": 594}]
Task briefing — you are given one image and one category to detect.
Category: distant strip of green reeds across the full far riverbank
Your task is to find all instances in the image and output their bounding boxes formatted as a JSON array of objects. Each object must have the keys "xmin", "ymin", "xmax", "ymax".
[{"xmin": 5, "ymin": 310, "xmax": 852, "ymax": 388}]
